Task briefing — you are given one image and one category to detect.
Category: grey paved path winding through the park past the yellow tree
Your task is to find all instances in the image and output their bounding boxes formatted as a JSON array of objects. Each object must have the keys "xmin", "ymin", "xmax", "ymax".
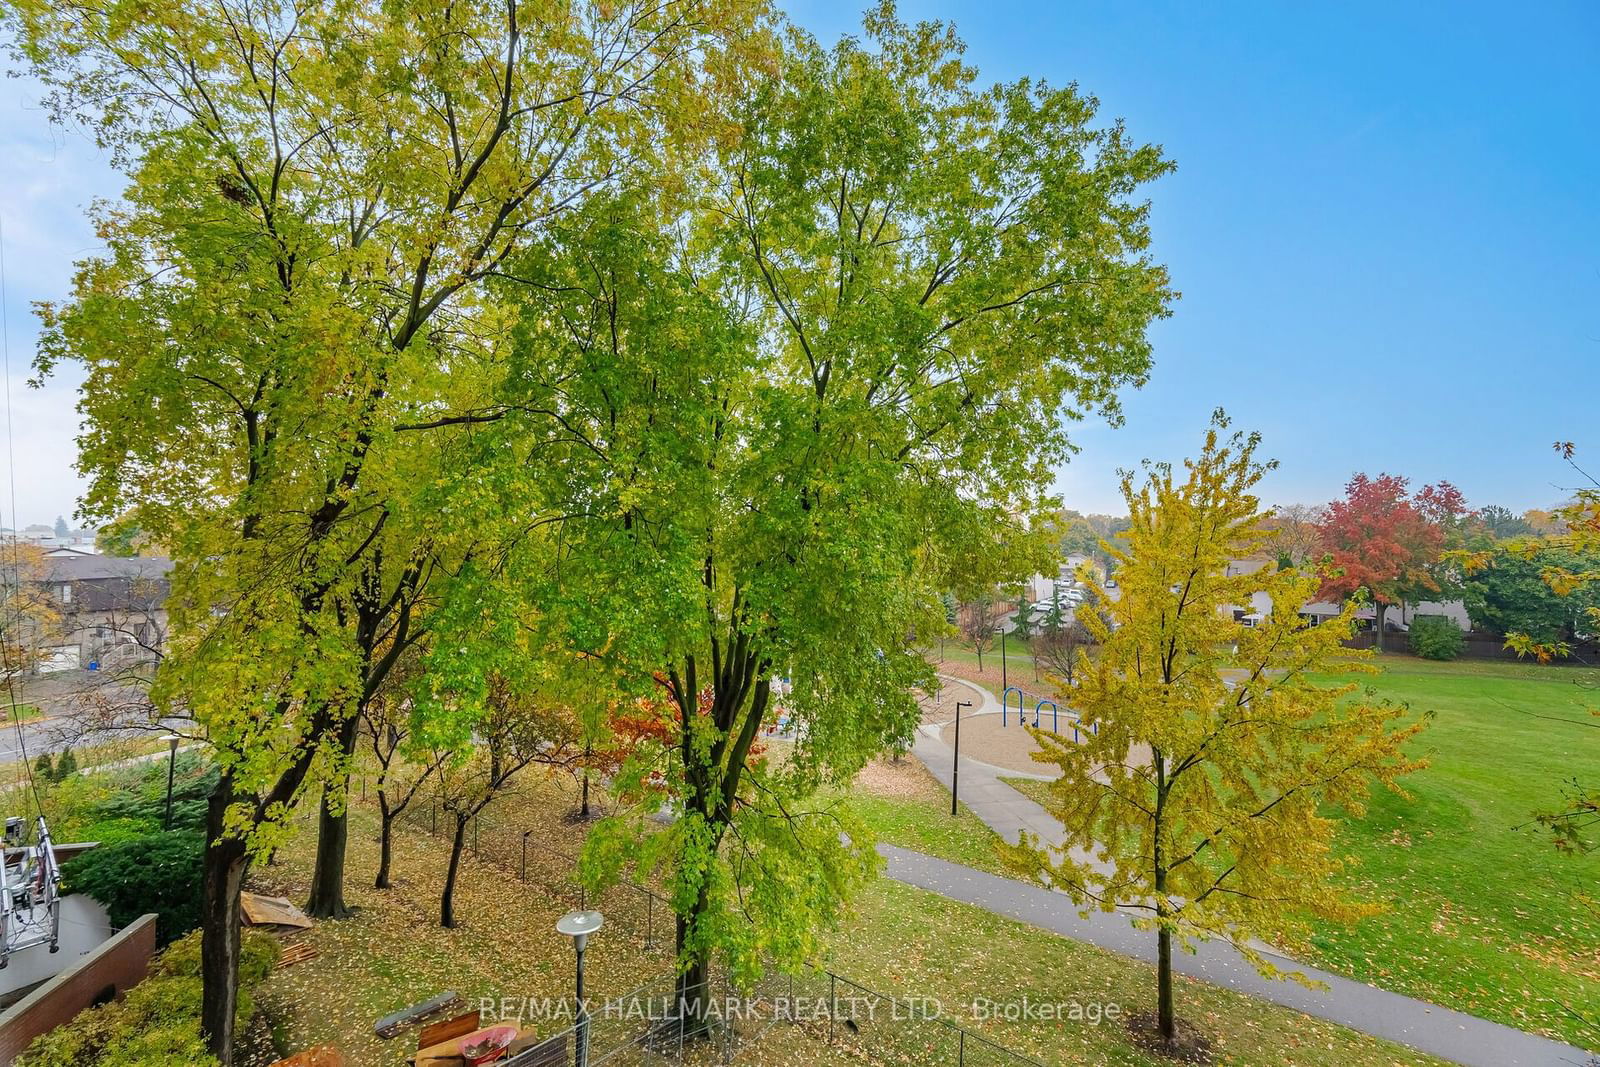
[{"xmin": 908, "ymin": 678, "xmax": 1600, "ymax": 1067}]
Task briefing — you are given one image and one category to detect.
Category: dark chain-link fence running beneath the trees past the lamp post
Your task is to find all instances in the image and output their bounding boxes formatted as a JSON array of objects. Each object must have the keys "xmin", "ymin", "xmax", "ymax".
[{"xmin": 400, "ymin": 798, "xmax": 1043, "ymax": 1067}]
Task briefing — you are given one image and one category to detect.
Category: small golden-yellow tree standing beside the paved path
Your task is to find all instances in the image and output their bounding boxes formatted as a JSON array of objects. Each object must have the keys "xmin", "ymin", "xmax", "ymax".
[{"xmin": 1008, "ymin": 411, "xmax": 1421, "ymax": 1046}]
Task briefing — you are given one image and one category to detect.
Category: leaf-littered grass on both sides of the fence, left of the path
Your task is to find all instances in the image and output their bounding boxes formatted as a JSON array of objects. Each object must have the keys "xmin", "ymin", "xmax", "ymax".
[{"xmin": 251, "ymin": 761, "xmax": 1465, "ymax": 1067}]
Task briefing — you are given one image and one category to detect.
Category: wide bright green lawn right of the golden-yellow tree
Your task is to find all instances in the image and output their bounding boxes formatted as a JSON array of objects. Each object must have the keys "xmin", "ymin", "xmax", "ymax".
[{"xmin": 1006, "ymin": 656, "xmax": 1600, "ymax": 1048}]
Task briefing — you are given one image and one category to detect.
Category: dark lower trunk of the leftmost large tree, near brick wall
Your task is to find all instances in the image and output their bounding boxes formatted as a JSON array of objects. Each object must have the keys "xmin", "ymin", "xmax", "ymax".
[{"xmin": 200, "ymin": 774, "xmax": 250, "ymax": 1067}]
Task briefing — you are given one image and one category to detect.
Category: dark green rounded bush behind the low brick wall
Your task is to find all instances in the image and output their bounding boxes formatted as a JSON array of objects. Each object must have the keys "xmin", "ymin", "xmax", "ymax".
[{"xmin": 61, "ymin": 830, "xmax": 205, "ymax": 945}]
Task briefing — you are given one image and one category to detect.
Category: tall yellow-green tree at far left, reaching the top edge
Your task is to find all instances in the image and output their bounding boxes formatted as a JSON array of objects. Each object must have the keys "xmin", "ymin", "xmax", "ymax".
[{"xmin": 3, "ymin": 0, "xmax": 749, "ymax": 1064}]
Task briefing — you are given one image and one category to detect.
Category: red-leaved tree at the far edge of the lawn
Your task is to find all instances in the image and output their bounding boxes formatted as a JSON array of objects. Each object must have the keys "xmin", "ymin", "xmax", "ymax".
[{"xmin": 1317, "ymin": 474, "xmax": 1466, "ymax": 649}]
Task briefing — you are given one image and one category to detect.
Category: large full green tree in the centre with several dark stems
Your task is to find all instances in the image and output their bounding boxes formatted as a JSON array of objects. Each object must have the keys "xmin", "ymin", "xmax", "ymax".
[{"xmin": 480, "ymin": 6, "xmax": 1171, "ymax": 1032}]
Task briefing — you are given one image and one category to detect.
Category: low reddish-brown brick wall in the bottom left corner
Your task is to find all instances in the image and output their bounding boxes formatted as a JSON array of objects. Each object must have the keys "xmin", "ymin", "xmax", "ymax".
[{"xmin": 0, "ymin": 915, "xmax": 155, "ymax": 1067}]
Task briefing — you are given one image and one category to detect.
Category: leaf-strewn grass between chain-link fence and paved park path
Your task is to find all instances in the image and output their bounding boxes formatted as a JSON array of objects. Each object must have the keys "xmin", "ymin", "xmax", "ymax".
[{"xmin": 832, "ymin": 760, "xmax": 1438, "ymax": 1067}]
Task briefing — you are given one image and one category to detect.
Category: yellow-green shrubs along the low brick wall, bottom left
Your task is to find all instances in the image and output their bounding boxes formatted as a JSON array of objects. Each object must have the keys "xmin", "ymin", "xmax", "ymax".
[{"xmin": 16, "ymin": 929, "xmax": 278, "ymax": 1067}]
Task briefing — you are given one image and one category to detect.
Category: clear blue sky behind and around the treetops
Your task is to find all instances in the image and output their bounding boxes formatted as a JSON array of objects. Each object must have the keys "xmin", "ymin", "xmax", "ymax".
[{"xmin": 0, "ymin": 0, "xmax": 1600, "ymax": 525}]
